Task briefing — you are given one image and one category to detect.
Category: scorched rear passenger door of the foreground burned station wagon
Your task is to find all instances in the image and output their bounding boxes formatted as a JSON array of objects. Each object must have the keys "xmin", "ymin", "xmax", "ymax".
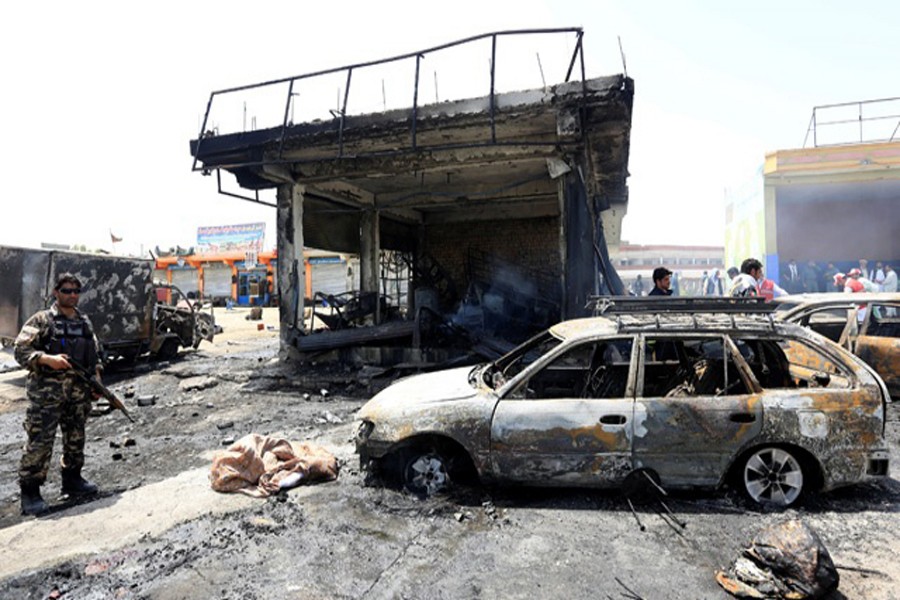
[{"xmin": 633, "ymin": 334, "xmax": 763, "ymax": 487}]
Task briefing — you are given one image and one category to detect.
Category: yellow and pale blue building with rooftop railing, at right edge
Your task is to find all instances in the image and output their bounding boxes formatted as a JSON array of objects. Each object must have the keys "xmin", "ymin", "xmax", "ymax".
[{"xmin": 725, "ymin": 99, "xmax": 900, "ymax": 285}]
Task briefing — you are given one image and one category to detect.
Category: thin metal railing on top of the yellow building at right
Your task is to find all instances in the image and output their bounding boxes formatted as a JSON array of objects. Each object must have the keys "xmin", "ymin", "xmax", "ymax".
[{"xmin": 803, "ymin": 97, "xmax": 900, "ymax": 148}]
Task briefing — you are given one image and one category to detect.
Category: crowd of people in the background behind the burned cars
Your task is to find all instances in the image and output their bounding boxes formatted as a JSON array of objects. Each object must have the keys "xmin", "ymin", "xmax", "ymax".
[{"xmin": 629, "ymin": 258, "xmax": 898, "ymax": 300}]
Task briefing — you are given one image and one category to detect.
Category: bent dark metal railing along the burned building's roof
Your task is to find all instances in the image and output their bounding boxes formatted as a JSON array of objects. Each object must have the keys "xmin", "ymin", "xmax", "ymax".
[{"xmin": 192, "ymin": 27, "xmax": 587, "ymax": 172}]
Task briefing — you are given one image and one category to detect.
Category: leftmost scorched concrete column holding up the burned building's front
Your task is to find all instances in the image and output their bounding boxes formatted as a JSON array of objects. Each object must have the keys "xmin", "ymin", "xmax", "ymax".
[{"xmin": 277, "ymin": 183, "xmax": 306, "ymax": 351}]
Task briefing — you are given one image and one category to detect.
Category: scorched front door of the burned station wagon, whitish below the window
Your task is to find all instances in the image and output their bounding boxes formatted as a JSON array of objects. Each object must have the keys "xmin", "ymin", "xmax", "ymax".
[{"xmin": 491, "ymin": 337, "xmax": 635, "ymax": 487}]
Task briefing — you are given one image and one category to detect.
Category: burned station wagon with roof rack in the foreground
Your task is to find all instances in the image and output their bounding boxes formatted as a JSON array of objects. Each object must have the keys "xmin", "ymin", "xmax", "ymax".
[{"xmin": 356, "ymin": 298, "xmax": 890, "ymax": 506}]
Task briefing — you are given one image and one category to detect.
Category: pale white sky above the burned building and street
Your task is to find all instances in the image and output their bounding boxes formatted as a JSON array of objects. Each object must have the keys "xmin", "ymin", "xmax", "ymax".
[{"xmin": 0, "ymin": 0, "xmax": 900, "ymax": 252}]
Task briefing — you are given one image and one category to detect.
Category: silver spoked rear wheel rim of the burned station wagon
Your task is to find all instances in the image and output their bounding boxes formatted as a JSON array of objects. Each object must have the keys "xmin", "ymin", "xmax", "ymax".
[{"xmin": 744, "ymin": 448, "xmax": 803, "ymax": 506}]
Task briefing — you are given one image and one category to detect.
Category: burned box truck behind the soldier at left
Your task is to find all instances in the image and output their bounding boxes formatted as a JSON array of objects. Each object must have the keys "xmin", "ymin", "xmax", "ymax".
[{"xmin": 0, "ymin": 246, "xmax": 215, "ymax": 362}]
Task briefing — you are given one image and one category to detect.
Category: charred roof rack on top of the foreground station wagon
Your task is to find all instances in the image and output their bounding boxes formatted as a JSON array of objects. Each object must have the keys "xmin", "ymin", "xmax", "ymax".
[{"xmin": 585, "ymin": 296, "xmax": 777, "ymax": 316}]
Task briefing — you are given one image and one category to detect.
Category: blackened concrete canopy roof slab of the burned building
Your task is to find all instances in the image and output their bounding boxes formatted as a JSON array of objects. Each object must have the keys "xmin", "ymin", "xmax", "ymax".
[{"xmin": 191, "ymin": 76, "xmax": 633, "ymax": 252}]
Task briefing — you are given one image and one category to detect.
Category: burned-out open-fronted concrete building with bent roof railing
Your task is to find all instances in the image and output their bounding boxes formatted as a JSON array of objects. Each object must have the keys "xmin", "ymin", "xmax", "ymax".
[{"xmin": 190, "ymin": 28, "xmax": 634, "ymax": 360}]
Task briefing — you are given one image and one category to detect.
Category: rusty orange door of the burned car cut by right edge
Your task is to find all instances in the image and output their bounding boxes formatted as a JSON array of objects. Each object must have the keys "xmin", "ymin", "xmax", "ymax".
[{"xmin": 853, "ymin": 302, "xmax": 900, "ymax": 398}]
